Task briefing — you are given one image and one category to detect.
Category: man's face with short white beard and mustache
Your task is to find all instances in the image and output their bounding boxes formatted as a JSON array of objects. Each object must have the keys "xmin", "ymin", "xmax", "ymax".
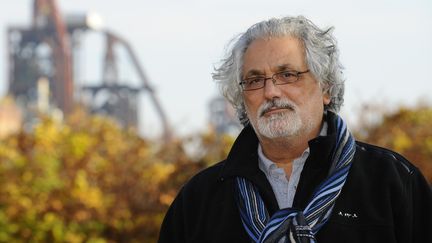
[{"xmin": 242, "ymin": 37, "xmax": 330, "ymax": 139}]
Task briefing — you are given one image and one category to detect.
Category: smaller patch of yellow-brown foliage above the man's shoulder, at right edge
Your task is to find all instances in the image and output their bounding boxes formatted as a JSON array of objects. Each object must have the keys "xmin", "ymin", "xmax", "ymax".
[{"xmin": 356, "ymin": 105, "xmax": 432, "ymax": 184}]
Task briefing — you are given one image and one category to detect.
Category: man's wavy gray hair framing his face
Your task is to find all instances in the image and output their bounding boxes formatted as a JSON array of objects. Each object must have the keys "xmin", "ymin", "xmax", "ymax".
[{"xmin": 212, "ymin": 16, "xmax": 344, "ymax": 125}]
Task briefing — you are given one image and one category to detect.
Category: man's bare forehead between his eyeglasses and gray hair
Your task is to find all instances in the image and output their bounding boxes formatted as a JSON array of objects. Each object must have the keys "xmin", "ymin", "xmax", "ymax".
[{"xmin": 242, "ymin": 36, "xmax": 306, "ymax": 75}]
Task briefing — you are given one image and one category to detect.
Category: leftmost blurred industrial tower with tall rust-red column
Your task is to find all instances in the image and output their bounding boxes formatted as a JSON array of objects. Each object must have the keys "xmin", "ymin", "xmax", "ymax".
[{"xmin": 7, "ymin": 0, "xmax": 73, "ymax": 114}]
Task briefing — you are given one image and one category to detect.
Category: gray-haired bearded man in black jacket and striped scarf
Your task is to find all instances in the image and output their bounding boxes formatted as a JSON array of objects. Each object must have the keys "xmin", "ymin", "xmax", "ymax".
[{"xmin": 159, "ymin": 16, "xmax": 432, "ymax": 242}]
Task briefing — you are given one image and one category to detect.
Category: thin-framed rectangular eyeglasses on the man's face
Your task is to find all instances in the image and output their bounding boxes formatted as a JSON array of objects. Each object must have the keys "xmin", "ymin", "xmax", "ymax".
[{"xmin": 239, "ymin": 69, "xmax": 309, "ymax": 91}]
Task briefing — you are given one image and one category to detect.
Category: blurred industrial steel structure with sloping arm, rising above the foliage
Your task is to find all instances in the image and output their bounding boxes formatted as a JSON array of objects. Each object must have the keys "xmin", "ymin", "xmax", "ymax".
[{"xmin": 7, "ymin": 0, "xmax": 171, "ymax": 139}]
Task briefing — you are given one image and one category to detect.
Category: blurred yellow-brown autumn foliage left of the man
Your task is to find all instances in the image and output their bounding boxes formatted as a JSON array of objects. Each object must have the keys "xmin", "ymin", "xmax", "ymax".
[{"xmin": 0, "ymin": 110, "xmax": 232, "ymax": 243}]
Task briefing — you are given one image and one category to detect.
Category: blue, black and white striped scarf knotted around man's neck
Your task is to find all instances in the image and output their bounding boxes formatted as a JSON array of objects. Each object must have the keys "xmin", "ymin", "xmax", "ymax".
[{"xmin": 236, "ymin": 116, "xmax": 355, "ymax": 243}]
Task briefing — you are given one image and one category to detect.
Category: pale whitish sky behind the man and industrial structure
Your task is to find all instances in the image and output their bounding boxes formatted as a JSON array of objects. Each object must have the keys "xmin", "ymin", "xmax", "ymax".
[{"xmin": 0, "ymin": 0, "xmax": 432, "ymax": 137}]
